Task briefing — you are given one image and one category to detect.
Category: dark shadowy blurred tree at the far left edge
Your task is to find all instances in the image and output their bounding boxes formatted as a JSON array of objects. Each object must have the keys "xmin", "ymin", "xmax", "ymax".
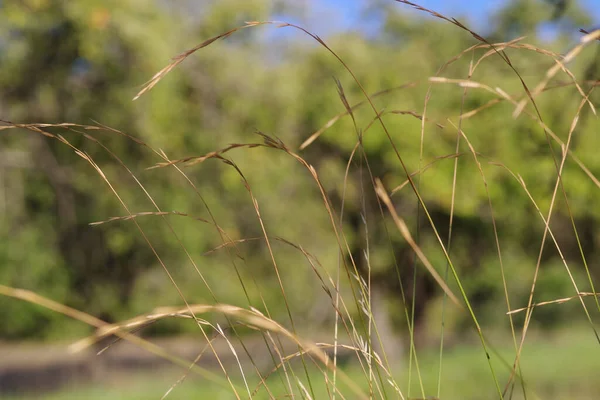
[{"xmin": 0, "ymin": 1, "xmax": 183, "ymax": 336}]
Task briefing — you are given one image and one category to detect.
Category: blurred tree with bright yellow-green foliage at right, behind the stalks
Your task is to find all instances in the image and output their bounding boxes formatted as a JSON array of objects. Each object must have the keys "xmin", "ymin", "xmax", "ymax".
[{"xmin": 302, "ymin": 0, "xmax": 598, "ymax": 337}]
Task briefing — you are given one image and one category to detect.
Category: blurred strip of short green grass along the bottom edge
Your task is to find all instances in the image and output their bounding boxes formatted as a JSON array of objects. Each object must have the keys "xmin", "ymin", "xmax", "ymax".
[{"xmin": 3, "ymin": 326, "xmax": 600, "ymax": 400}]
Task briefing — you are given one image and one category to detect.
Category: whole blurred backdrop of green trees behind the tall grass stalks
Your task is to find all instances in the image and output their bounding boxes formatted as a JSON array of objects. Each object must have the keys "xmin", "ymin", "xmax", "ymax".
[{"xmin": 0, "ymin": 0, "xmax": 600, "ymax": 398}]
